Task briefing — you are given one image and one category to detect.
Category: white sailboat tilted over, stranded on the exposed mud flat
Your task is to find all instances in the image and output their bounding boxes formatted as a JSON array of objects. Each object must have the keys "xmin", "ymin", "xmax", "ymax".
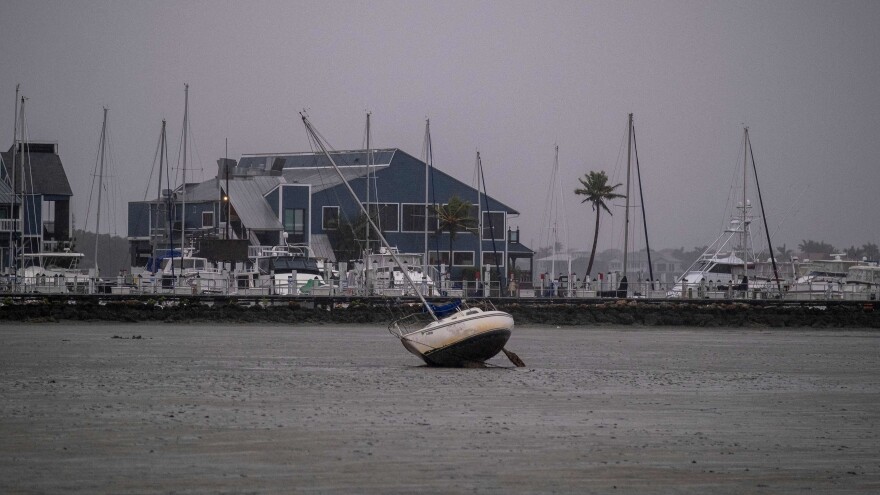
[{"xmin": 300, "ymin": 113, "xmax": 524, "ymax": 367}]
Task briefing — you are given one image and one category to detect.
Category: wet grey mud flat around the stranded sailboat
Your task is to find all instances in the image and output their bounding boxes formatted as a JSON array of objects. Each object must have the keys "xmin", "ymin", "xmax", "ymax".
[{"xmin": 0, "ymin": 323, "xmax": 880, "ymax": 494}]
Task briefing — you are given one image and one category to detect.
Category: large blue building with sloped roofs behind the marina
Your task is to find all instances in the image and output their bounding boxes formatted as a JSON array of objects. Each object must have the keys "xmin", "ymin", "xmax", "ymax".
[{"xmin": 128, "ymin": 148, "xmax": 533, "ymax": 279}]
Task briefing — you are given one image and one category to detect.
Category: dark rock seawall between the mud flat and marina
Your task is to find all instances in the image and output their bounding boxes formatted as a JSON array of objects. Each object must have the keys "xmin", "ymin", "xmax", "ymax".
[{"xmin": 0, "ymin": 295, "xmax": 880, "ymax": 328}]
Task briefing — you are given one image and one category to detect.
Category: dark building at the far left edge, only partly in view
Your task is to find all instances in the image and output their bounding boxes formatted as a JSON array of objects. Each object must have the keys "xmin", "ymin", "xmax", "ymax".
[{"xmin": 0, "ymin": 142, "xmax": 73, "ymax": 271}]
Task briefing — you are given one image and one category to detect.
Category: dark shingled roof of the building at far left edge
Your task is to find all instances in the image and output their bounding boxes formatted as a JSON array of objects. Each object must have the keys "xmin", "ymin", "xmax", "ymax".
[{"xmin": 3, "ymin": 143, "xmax": 73, "ymax": 196}]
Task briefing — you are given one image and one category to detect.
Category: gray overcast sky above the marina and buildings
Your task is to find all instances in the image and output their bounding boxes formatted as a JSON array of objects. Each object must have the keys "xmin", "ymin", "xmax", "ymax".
[{"xmin": 0, "ymin": 0, "xmax": 880, "ymax": 256}]
